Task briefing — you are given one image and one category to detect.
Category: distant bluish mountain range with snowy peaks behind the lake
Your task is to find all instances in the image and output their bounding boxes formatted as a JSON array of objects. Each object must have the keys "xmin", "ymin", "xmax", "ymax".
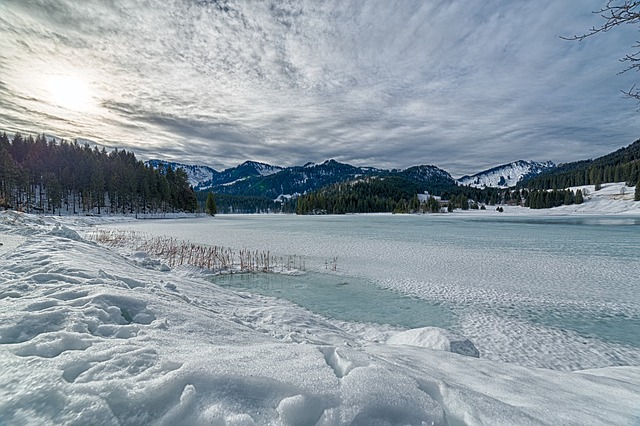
[{"xmin": 147, "ymin": 160, "xmax": 556, "ymax": 199}]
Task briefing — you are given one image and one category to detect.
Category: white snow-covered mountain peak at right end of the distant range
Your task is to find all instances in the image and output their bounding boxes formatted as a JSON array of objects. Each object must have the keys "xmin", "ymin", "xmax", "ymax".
[{"xmin": 457, "ymin": 160, "xmax": 556, "ymax": 188}]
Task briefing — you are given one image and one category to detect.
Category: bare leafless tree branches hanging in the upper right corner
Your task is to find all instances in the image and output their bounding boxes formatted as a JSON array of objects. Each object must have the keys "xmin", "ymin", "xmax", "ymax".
[{"xmin": 561, "ymin": 0, "xmax": 640, "ymax": 101}]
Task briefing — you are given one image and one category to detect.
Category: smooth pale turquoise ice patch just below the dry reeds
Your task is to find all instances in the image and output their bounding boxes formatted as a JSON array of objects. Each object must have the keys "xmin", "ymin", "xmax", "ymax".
[{"xmin": 212, "ymin": 272, "xmax": 454, "ymax": 328}]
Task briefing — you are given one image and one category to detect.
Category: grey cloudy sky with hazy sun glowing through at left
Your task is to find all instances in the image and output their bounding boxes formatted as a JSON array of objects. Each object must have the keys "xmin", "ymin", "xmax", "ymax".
[{"xmin": 0, "ymin": 0, "xmax": 640, "ymax": 177}]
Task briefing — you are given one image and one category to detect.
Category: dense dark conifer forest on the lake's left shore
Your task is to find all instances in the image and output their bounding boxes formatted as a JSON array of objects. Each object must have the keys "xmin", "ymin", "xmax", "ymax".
[{"xmin": 0, "ymin": 133, "xmax": 197, "ymax": 214}]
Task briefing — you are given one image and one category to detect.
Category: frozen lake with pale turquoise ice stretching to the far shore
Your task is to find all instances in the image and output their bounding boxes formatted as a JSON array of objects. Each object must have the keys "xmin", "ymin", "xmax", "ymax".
[{"xmin": 107, "ymin": 214, "xmax": 640, "ymax": 370}]
